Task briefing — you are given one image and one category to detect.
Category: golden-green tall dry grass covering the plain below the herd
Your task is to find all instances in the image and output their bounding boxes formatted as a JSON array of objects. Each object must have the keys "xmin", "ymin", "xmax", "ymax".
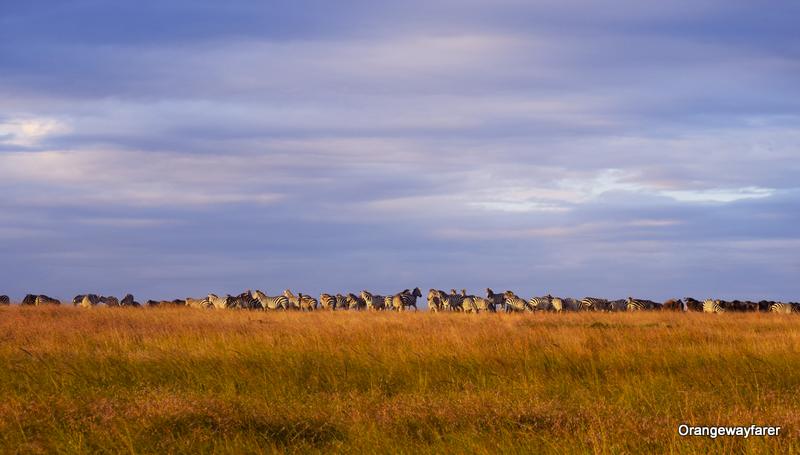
[{"xmin": 0, "ymin": 307, "xmax": 800, "ymax": 453}]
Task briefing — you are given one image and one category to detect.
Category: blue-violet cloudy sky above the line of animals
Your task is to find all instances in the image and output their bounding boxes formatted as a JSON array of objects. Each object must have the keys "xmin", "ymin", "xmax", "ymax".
[{"xmin": 0, "ymin": 0, "xmax": 800, "ymax": 300}]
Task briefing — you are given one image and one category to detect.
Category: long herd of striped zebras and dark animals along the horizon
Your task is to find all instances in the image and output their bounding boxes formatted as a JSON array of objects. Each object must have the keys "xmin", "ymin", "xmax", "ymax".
[{"xmin": 0, "ymin": 288, "xmax": 800, "ymax": 314}]
